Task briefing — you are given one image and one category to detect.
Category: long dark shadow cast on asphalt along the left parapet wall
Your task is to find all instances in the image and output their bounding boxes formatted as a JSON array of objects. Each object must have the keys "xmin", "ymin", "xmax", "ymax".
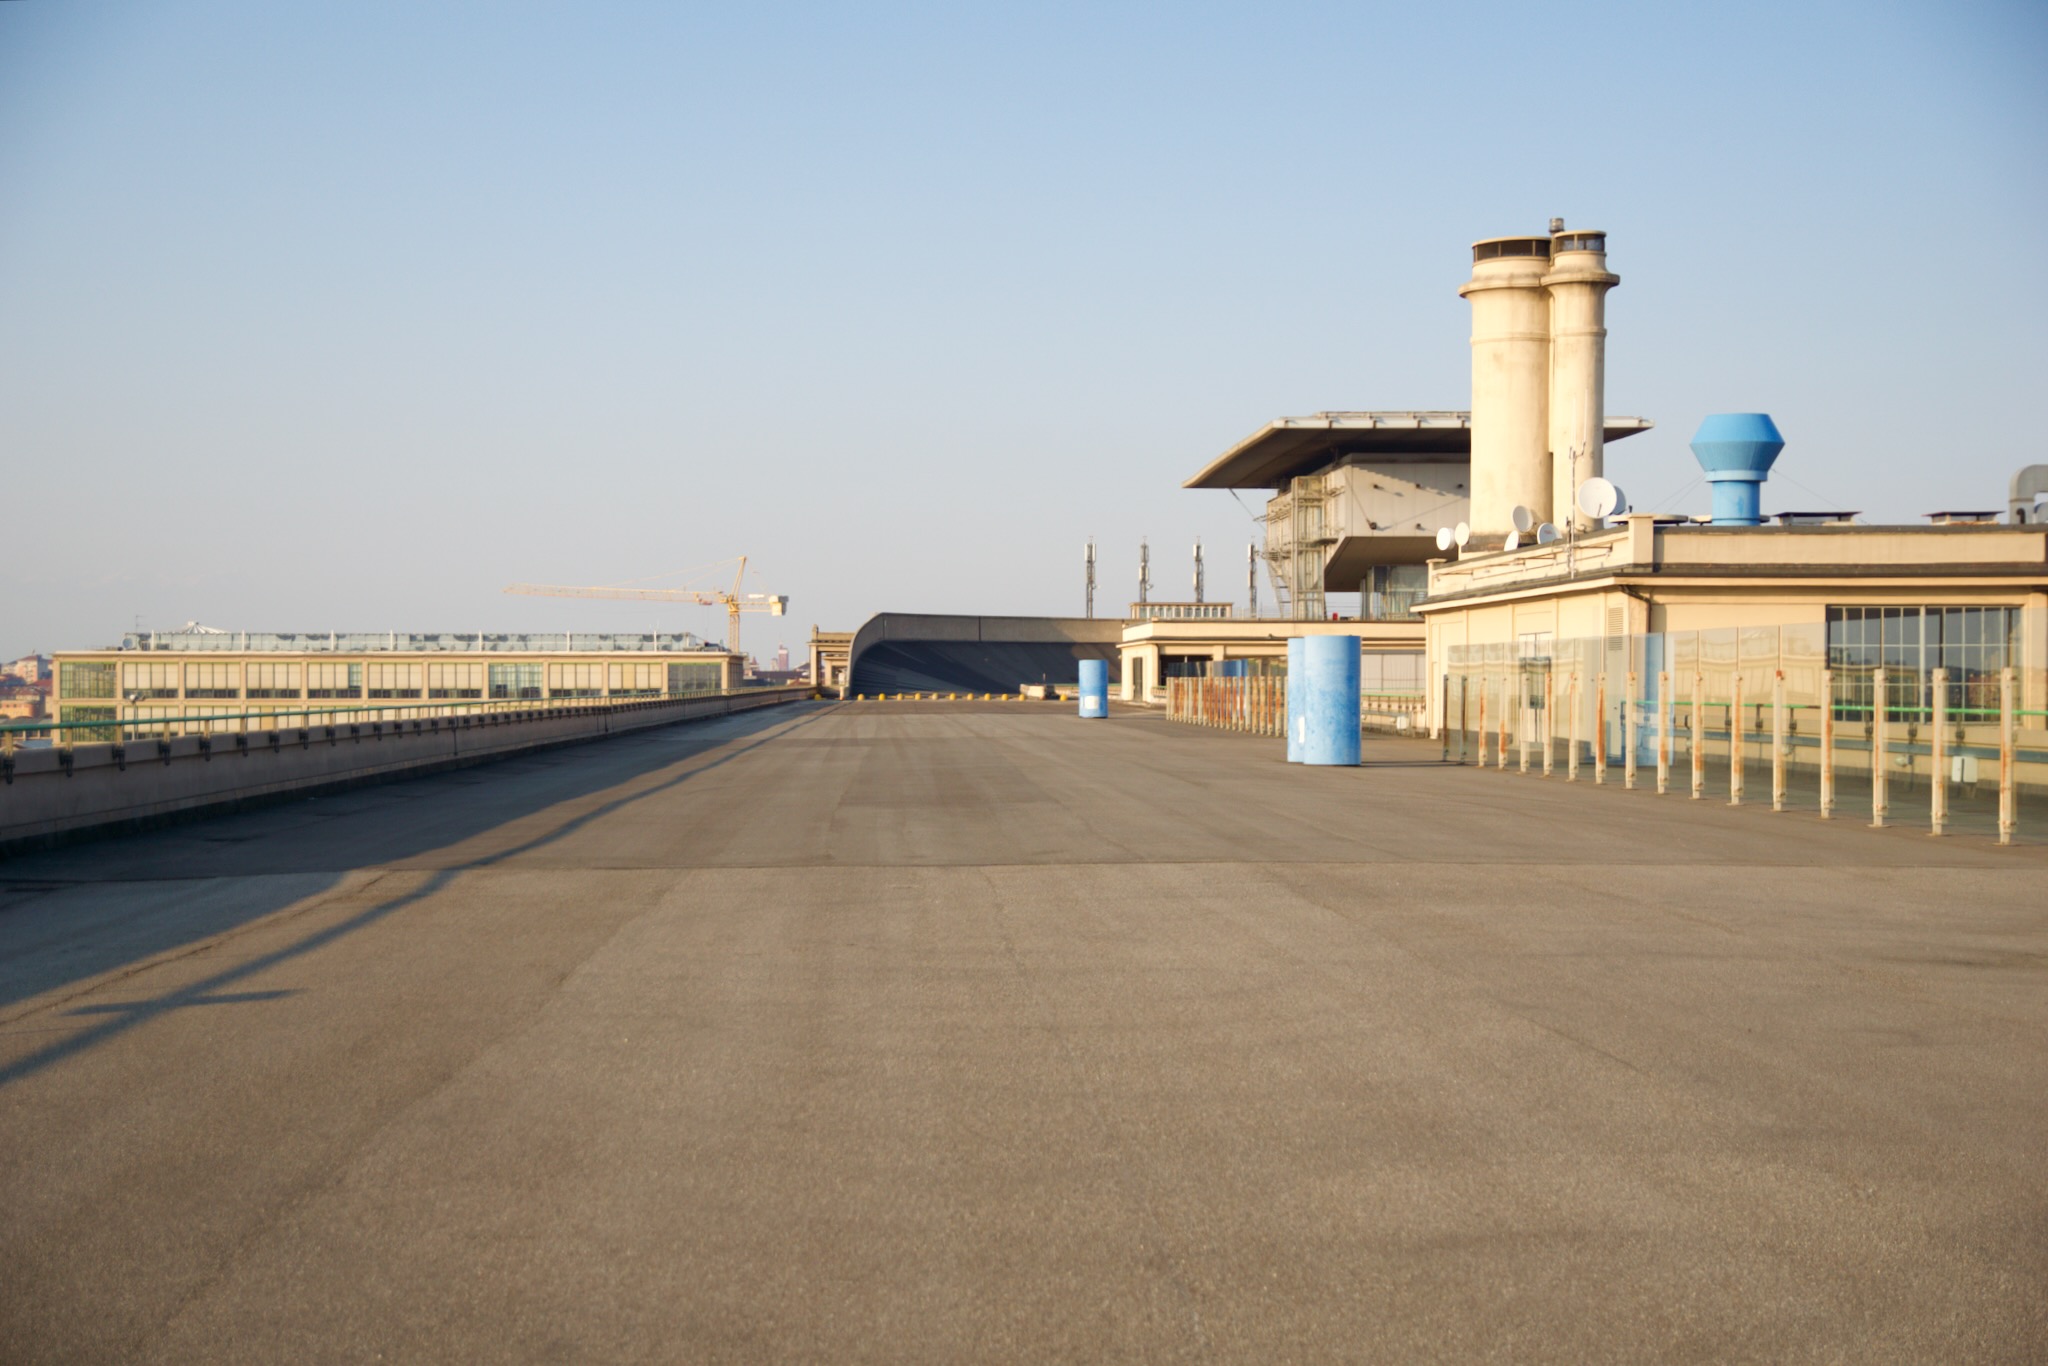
[{"xmin": 0, "ymin": 705, "xmax": 825, "ymax": 1036}]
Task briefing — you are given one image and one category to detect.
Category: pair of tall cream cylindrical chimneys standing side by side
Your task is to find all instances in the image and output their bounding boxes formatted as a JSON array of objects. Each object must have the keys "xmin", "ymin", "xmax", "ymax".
[{"xmin": 1458, "ymin": 219, "xmax": 1622, "ymax": 541}]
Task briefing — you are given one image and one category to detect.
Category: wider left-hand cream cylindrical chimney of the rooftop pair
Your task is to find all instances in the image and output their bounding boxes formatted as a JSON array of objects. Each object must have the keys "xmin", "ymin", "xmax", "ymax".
[{"xmin": 1458, "ymin": 238, "xmax": 1550, "ymax": 539}]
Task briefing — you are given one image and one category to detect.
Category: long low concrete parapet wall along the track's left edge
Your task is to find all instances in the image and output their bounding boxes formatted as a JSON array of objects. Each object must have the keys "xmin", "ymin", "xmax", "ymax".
[{"xmin": 0, "ymin": 688, "xmax": 813, "ymax": 856}]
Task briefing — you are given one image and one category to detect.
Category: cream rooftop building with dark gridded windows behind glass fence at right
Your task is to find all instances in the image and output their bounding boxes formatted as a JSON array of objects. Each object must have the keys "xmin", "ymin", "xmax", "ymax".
[{"xmin": 1415, "ymin": 516, "xmax": 2048, "ymax": 749}]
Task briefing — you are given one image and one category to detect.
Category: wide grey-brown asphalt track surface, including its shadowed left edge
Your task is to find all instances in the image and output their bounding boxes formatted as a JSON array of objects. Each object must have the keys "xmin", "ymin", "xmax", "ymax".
[{"xmin": 0, "ymin": 702, "xmax": 2048, "ymax": 1362}]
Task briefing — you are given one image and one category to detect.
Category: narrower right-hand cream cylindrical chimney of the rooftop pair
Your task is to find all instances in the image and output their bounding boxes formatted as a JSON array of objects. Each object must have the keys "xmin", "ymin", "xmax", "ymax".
[{"xmin": 1542, "ymin": 219, "xmax": 1622, "ymax": 530}]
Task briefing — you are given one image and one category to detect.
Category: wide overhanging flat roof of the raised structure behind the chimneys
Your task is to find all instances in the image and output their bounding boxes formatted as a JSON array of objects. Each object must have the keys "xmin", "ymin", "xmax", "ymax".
[{"xmin": 1182, "ymin": 412, "xmax": 1655, "ymax": 489}]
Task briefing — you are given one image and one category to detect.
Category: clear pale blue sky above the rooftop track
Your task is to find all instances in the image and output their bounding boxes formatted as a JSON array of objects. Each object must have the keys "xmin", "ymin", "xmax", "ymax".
[{"xmin": 0, "ymin": 0, "xmax": 2048, "ymax": 653}]
